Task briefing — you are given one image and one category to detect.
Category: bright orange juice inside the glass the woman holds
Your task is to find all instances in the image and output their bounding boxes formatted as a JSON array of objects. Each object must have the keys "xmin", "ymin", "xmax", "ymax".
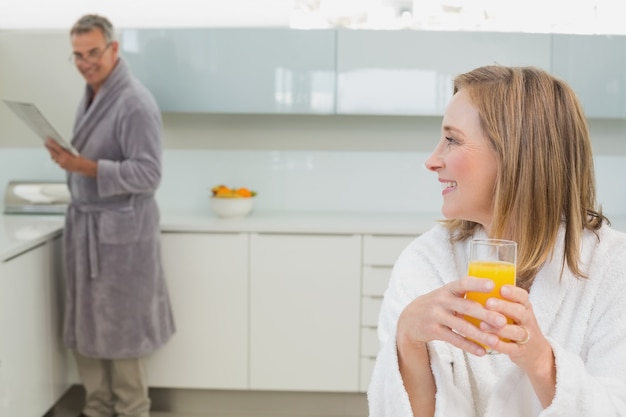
[{"xmin": 465, "ymin": 261, "xmax": 515, "ymax": 348}]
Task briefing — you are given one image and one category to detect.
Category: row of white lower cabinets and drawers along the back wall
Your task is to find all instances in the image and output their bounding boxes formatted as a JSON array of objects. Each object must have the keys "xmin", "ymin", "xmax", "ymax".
[{"xmin": 143, "ymin": 224, "xmax": 414, "ymax": 392}]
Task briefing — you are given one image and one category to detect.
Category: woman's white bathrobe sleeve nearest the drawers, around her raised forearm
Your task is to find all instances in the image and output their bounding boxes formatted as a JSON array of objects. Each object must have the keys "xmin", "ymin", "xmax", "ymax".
[{"xmin": 368, "ymin": 226, "xmax": 473, "ymax": 417}]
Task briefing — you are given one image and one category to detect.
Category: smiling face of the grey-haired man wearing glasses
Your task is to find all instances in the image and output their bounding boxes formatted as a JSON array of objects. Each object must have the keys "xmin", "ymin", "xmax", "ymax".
[{"xmin": 71, "ymin": 29, "xmax": 119, "ymax": 92}]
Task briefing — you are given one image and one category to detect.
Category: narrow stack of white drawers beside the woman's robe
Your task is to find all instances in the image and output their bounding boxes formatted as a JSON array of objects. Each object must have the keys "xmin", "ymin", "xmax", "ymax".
[{"xmin": 359, "ymin": 235, "xmax": 416, "ymax": 392}]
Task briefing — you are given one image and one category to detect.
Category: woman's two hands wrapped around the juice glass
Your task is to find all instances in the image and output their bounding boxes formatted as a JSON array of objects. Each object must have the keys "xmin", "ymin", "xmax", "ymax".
[{"xmin": 397, "ymin": 276, "xmax": 556, "ymax": 407}]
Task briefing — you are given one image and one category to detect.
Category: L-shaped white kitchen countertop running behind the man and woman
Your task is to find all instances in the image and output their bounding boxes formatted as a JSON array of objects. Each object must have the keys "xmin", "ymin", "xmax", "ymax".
[{"xmin": 0, "ymin": 210, "xmax": 626, "ymax": 262}]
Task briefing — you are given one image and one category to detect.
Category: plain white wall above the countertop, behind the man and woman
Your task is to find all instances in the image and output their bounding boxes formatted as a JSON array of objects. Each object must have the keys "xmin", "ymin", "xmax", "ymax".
[{"xmin": 0, "ymin": 31, "xmax": 626, "ymax": 216}]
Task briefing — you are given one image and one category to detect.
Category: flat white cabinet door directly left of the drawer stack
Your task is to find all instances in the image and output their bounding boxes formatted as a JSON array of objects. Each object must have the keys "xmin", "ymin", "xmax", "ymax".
[{"xmin": 250, "ymin": 234, "xmax": 361, "ymax": 391}]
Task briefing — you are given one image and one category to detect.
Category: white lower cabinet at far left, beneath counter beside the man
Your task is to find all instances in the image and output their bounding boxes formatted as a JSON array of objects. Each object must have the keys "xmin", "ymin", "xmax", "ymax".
[{"xmin": 0, "ymin": 237, "xmax": 72, "ymax": 417}]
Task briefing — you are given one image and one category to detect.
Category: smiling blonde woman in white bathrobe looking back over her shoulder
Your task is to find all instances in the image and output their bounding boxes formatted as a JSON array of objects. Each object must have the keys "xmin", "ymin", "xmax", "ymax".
[{"xmin": 368, "ymin": 66, "xmax": 626, "ymax": 417}]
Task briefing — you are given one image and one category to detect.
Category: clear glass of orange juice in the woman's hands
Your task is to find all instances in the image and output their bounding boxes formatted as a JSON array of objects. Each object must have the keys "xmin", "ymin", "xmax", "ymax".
[{"xmin": 465, "ymin": 239, "xmax": 517, "ymax": 354}]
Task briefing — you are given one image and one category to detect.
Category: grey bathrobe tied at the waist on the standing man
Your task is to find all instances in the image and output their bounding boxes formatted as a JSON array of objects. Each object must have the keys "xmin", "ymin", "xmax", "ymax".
[{"xmin": 64, "ymin": 59, "xmax": 175, "ymax": 359}]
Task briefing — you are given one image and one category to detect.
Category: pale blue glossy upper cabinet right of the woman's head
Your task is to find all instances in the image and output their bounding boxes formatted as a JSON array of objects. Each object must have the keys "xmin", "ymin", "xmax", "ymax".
[{"xmin": 552, "ymin": 35, "xmax": 626, "ymax": 118}]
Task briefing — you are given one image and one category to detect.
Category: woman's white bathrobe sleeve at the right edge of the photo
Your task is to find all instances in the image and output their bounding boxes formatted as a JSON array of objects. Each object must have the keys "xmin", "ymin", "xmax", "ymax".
[{"xmin": 540, "ymin": 226, "xmax": 626, "ymax": 417}]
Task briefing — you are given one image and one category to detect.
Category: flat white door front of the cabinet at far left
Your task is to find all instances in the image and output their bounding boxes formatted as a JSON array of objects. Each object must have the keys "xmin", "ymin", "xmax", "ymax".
[{"xmin": 0, "ymin": 243, "xmax": 58, "ymax": 417}]
